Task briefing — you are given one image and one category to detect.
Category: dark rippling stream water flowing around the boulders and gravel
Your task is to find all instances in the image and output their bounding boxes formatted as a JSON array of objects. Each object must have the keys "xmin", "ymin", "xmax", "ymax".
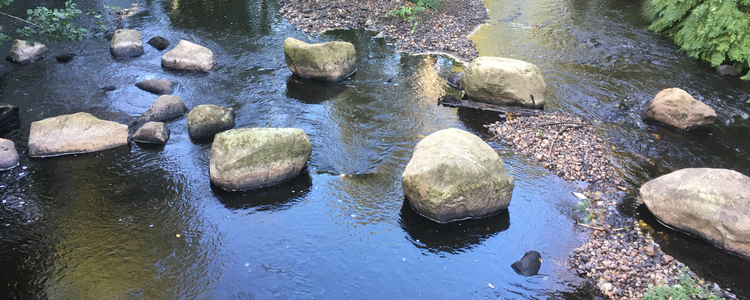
[{"xmin": 0, "ymin": 0, "xmax": 750, "ymax": 299}]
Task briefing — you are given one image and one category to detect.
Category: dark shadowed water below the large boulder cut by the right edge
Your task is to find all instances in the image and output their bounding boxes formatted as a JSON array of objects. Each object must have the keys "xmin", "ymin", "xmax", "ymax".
[{"xmin": 636, "ymin": 204, "xmax": 750, "ymax": 297}]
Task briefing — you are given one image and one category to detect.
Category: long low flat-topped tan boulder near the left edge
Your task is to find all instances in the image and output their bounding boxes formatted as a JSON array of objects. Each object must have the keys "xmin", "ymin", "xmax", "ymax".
[{"xmin": 29, "ymin": 112, "xmax": 128, "ymax": 157}]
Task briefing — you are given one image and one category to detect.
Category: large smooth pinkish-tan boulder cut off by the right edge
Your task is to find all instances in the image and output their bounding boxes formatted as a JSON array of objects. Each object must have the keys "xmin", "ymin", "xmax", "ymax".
[{"xmin": 641, "ymin": 168, "xmax": 750, "ymax": 258}]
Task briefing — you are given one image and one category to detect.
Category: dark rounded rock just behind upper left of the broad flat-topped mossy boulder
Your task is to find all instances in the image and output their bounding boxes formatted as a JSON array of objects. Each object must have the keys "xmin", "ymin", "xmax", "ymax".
[{"xmin": 188, "ymin": 104, "xmax": 234, "ymax": 140}]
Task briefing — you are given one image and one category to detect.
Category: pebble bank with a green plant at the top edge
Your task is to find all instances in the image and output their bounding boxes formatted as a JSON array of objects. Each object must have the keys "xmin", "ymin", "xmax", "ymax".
[{"xmin": 279, "ymin": 0, "xmax": 487, "ymax": 62}]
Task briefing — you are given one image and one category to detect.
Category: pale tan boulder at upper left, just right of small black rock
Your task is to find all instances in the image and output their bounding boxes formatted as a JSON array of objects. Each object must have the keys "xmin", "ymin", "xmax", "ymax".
[{"xmin": 161, "ymin": 40, "xmax": 216, "ymax": 73}]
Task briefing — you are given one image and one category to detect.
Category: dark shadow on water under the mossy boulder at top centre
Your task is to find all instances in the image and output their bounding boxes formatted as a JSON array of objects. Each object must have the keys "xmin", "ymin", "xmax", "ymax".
[{"xmin": 286, "ymin": 75, "xmax": 346, "ymax": 104}]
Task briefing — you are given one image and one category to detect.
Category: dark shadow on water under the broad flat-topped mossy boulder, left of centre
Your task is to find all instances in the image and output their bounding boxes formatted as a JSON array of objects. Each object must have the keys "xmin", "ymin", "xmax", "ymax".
[{"xmin": 211, "ymin": 169, "xmax": 312, "ymax": 211}]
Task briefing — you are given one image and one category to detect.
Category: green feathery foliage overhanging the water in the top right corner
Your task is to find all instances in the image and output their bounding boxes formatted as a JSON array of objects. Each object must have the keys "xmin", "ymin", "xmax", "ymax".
[{"xmin": 643, "ymin": 0, "xmax": 750, "ymax": 80}]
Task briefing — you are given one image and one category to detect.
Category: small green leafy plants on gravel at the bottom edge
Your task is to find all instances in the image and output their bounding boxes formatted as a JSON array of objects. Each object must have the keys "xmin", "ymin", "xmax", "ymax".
[{"xmin": 643, "ymin": 267, "xmax": 724, "ymax": 300}]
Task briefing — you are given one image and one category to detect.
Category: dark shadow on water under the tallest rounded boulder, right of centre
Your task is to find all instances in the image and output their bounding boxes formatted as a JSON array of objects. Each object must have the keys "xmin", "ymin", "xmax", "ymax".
[{"xmin": 399, "ymin": 199, "xmax": 510, "ymax": 254}]
